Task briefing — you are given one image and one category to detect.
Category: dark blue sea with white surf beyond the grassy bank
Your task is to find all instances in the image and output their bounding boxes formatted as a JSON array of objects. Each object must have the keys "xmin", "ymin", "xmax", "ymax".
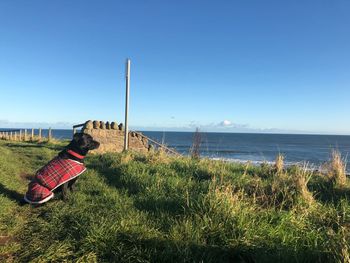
[{"xmin": 0, "ymin": 129, "xmax": 350, "ymax": 172}]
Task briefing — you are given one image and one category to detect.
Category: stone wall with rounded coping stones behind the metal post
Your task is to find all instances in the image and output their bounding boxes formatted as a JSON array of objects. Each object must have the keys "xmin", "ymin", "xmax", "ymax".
[{"xmin": 82, "ymin": 121, "xmax": 149, "ymax": 153}]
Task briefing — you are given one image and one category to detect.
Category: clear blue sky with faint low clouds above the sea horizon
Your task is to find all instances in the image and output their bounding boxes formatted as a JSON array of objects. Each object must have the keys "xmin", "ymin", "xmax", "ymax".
[{"xmin": 0, "ymin": 0, "xmax": 350, "ymax": 134}]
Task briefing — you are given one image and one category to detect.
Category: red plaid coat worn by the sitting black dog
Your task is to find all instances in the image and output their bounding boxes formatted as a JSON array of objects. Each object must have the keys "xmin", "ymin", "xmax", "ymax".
[{"xmin": 24, "ymin": 157, "xmax": 86, "ymax": 204}]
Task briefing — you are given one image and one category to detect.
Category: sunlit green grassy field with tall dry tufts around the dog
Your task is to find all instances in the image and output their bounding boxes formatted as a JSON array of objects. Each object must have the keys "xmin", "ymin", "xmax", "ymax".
[{"xmin": 0, "ymin": 141, "xmax": 350, "ymax": 262}]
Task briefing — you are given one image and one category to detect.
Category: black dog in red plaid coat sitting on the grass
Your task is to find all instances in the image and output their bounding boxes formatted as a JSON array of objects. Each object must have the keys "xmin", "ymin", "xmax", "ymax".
[{"xmin": 24, "ymin": 133, "xmax": 100, "ymax": 204}]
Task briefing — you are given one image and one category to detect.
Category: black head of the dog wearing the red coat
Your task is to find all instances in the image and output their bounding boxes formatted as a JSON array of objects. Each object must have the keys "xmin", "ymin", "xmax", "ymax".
[{"xmin": 67, "ymin": 133, "xmax": 100, "ymax": 156}]
